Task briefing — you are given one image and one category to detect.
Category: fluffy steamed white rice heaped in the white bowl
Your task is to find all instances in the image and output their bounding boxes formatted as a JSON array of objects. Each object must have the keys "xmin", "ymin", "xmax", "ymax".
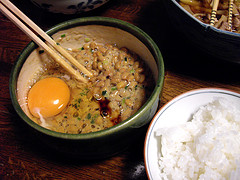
[{"xmin": 156, "ymin": 98, "xmax": 240, "ymax": 180}]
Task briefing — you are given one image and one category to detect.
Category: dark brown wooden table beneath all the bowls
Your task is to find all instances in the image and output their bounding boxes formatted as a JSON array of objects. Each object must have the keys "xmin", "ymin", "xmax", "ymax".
[{"xmin": 0, "ymin": 0, "xmax": 240, "ymax": 179}]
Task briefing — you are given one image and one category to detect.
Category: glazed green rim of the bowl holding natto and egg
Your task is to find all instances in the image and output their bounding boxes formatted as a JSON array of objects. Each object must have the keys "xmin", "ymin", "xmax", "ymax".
[{"xmin": 9, "ymin": 17, "xmax": 164, "ymax": 140}]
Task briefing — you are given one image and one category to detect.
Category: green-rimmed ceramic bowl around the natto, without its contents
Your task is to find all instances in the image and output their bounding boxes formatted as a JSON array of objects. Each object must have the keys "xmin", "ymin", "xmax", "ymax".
[{"xmin": 10, "ymin": 17, "xmax": 164, "ymax": 158}]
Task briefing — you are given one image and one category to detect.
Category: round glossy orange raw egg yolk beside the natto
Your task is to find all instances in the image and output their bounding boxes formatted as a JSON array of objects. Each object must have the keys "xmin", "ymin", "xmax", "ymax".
[{"xmin": 28, "ymin": 77, "xmax": 70, "ymax": 118}]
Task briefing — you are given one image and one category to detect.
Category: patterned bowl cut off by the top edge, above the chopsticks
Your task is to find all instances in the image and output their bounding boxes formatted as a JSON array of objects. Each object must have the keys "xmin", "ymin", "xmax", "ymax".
[{"xmin": 31, "ymin": 0, "xmax": 109, "ymax": 14}]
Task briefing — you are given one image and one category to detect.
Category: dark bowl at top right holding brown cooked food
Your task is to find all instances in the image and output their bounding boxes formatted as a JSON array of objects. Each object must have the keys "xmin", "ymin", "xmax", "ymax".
[{"xmin": 163, "ymin": 0, "xmax": 240, "ymax": 63}]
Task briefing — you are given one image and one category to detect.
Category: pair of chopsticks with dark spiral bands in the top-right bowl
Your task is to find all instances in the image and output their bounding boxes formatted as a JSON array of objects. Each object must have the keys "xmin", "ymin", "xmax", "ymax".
[{"xmin": 210, "ymin": 0, "xmax": 233, "ymax": 31}]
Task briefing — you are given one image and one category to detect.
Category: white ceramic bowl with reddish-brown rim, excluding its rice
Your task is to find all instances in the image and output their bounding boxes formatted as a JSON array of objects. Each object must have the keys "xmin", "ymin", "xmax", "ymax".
[{"xmin": 144, "ymin": 88, "xmax": 240, "ymax": 180}]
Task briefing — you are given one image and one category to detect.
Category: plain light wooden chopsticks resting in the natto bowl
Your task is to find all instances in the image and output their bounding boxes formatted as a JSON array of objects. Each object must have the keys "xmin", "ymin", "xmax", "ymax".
[{"xmin": 0, "ymin": 0, "xmax": 92, "ymax": 83}]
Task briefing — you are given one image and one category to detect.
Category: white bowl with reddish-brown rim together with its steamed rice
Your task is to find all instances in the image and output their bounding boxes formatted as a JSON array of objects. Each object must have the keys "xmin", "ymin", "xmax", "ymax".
[{"xmin": 144, "ymin": 88, "xmax": 240, "ymax": 180}]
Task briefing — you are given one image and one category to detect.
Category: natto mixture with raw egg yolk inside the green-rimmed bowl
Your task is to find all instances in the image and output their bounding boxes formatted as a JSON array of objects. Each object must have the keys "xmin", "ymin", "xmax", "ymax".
[{"xmin": 18, "ymin": 26, "xmax": 155, "ymax": 134}]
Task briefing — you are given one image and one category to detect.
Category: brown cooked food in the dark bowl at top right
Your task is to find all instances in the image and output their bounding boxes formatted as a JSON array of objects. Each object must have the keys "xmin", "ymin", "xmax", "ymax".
[{"xmin": 179, "ymin": 0, "xmax": 240, "ymax": 33}]
